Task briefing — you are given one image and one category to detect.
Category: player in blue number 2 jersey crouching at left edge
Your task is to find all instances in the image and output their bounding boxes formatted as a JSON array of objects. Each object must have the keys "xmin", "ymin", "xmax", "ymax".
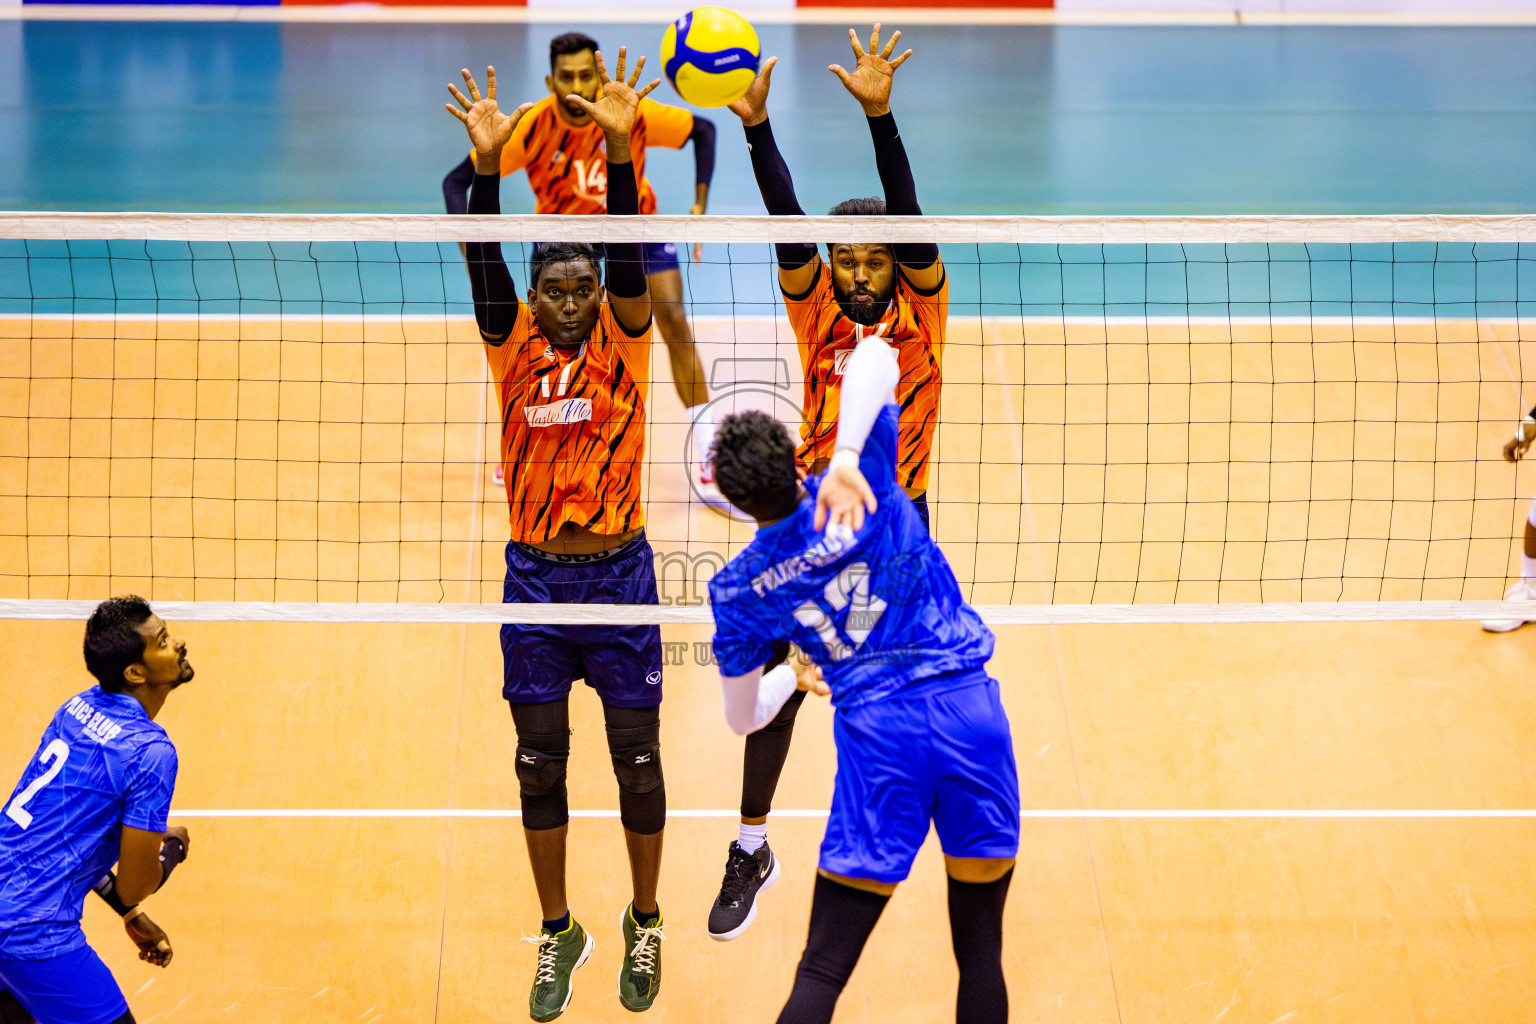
[{"xmin": 0, "ymin": 597, "xmax": 192, "ymax": 1024}]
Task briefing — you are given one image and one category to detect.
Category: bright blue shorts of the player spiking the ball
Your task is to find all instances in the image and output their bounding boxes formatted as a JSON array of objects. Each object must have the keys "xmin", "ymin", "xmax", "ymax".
[{"xmin": 820, "ymin": 669, "xmax": 1018, "ymax": 883}]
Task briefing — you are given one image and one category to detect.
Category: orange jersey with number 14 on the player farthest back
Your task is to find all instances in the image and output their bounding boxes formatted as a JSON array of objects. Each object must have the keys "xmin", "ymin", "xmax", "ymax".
[{"xmin": 501, "ymin": 95, "xmax": 693, "ymax": 213}]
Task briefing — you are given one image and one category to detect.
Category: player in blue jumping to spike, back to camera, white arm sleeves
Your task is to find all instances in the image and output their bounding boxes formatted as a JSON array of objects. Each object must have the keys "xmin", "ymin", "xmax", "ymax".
[{"xmin": 710, "ymin": 336, "xmax": 1018, "ymax": 1024}]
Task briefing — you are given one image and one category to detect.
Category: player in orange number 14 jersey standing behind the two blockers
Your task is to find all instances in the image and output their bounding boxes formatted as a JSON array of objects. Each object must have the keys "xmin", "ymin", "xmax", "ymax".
[{"xmin": 442, "ymin": 32, "xmax": 720, "ymax": 504}]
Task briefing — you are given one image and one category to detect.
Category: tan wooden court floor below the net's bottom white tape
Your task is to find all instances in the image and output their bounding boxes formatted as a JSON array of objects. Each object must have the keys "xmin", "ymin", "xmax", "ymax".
[{"xmin": 0, "ymin": 622, "xmax": 1536, "ymax": 1024}]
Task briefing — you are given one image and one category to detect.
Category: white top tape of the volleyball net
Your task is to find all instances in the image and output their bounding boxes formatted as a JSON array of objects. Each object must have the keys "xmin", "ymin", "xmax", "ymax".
[{"xmin": 9, "ymin": 211, "xmax": 1536, "ymax": 246}]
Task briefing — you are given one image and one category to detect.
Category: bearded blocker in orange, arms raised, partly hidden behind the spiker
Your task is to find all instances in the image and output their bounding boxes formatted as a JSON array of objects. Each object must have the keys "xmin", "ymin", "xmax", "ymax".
[{"xmin": 710, "ymin": 25, "xmax": 949, "ymax": 940}]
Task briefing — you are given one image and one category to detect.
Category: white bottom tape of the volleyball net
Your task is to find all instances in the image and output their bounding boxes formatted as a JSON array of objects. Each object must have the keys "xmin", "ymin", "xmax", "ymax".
[{"xmin": 0, "ymin": 597, "xmax": 1510, "ymax": 626}]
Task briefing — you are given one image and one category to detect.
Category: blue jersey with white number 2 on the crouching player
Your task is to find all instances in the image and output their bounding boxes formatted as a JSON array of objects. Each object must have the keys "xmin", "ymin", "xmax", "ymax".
[{"xmin": 0, "ymin": 686, "xmax": 177, "ymax": 960}]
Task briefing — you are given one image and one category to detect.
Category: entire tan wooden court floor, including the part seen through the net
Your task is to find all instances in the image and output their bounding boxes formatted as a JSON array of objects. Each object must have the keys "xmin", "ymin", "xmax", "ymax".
[{"xmin": 0, "ymin": 316, "xmax": 1536, "ymax": 1024}]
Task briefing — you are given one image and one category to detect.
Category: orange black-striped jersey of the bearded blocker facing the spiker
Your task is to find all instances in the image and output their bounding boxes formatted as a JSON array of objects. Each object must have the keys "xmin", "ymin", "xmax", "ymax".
[{"xmin": 783, "ymin": 263, "xmax": 949, "ymax": 491}]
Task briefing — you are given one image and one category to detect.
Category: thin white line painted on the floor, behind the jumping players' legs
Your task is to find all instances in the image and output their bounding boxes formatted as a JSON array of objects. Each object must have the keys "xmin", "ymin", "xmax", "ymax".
[{"xmin": 170, "ymin": 808, "xmax": 1536, "ymax": 821}]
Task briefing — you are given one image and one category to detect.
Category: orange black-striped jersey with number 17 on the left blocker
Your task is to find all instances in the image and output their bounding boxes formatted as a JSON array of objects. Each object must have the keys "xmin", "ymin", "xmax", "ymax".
[{"xmin": 485, "ymin": 302, "xmax": 651, "ymax": 543}]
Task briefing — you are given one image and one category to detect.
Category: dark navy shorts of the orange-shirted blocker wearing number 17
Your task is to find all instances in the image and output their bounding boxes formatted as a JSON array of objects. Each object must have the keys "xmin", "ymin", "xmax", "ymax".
[{"xmin": 501, "ymin": 534, "xmax": 662, "ymax": 708}]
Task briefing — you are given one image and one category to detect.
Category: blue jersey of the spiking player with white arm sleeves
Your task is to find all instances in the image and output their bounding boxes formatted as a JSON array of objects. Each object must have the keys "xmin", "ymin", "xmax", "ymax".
[{"xmin": 710, "ymin": 405, "xmax": 992, "ymax": 708}]
